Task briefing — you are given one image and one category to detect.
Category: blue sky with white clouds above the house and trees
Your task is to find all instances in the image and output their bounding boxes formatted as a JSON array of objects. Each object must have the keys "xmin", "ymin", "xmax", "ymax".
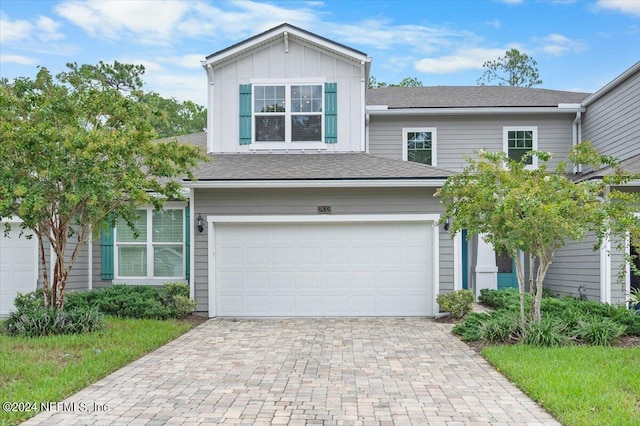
[{"xmin": 0, "ymin": 0, "xmax": 640, "ymax": 105}]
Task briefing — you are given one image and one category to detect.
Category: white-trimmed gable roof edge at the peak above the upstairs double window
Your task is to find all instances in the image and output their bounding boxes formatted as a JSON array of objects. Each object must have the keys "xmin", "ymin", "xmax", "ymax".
[{"xmin": 203, "ymin": 23, "xmax": 371, "ymax": 65}]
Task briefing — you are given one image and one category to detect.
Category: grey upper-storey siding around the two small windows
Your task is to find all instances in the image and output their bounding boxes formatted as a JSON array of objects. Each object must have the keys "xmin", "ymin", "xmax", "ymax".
[{"xmin": 368, "ymin": 114, "xmax": 575, "ymax": 171}]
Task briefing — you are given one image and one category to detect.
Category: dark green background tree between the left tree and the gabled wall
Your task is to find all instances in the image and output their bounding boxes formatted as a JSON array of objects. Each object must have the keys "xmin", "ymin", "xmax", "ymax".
[{"xmin": 143, "ymin": 92, "xmax": 207, "ymax": 138}]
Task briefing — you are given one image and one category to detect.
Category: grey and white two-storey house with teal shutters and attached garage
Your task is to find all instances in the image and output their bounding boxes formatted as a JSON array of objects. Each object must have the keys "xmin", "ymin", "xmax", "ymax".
[{"xmin": 0, "ymin": 24, "xmax": 640, "ymax": 317}]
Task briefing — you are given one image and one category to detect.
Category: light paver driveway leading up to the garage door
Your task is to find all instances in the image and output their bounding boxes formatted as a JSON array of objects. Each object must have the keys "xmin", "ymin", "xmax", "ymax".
[{"xmin": 26, "ymin": 319, "xmax": 557, "ymax": 425}]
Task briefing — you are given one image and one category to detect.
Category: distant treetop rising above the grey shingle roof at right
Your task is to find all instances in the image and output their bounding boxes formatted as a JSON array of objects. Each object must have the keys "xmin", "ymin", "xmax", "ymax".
[{"xmin": 477, "ymin": 49, "xmax": 542, "ymax": 87}]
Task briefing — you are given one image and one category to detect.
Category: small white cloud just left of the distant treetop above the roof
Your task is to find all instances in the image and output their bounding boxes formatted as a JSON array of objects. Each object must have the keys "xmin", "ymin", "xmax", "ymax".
[{"xmin": 415, "ymin": 47, "xmax": 508, "ymax": 74}]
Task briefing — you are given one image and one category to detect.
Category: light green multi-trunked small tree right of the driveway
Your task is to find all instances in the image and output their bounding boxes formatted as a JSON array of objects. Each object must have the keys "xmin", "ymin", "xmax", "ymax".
[{"xmin": 439, "ymin": 143, "xmax": 640, "ymax": 325}]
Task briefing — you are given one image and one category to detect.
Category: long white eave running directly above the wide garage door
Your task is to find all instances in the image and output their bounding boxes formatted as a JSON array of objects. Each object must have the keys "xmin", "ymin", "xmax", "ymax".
[{"xmin": 183, "ymin": 177, "xmax": 446, "ymax": 189}]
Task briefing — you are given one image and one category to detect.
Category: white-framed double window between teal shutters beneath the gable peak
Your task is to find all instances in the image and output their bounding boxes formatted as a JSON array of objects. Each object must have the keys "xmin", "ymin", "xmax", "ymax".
[{"xmin": 253, "ymin": 84, "xmax": 324, "ymax": 148}]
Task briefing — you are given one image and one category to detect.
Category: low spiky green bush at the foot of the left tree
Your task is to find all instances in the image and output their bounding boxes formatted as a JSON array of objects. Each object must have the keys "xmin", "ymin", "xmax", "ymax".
[{"xmin": 3, "ymin": 307, "xmax": 104, "ymax": 337}]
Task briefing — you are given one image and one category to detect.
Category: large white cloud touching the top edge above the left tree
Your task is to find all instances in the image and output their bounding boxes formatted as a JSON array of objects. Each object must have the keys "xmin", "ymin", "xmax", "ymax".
[{"xmin": 55, "ymin": 0, "xmax": 190, "ymax": 44}]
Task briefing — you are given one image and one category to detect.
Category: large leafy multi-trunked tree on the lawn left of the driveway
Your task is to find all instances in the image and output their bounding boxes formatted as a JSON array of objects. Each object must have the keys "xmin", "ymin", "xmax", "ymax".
[{"xmin": 0, "ymin": 62, "xmax": 206, "ymax": 309}]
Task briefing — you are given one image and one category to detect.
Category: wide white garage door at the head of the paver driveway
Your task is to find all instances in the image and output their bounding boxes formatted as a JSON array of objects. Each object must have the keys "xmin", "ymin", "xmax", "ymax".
[{"xmin": 214, "ymin": 222, "xmax": 433, "ymax": 317}]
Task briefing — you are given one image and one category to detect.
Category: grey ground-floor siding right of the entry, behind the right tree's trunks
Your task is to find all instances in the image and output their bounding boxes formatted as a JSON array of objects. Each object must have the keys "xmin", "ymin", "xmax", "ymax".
[{"xmin": 544, "ymin": 235, "xmax": 600, "ymax": 300}]
